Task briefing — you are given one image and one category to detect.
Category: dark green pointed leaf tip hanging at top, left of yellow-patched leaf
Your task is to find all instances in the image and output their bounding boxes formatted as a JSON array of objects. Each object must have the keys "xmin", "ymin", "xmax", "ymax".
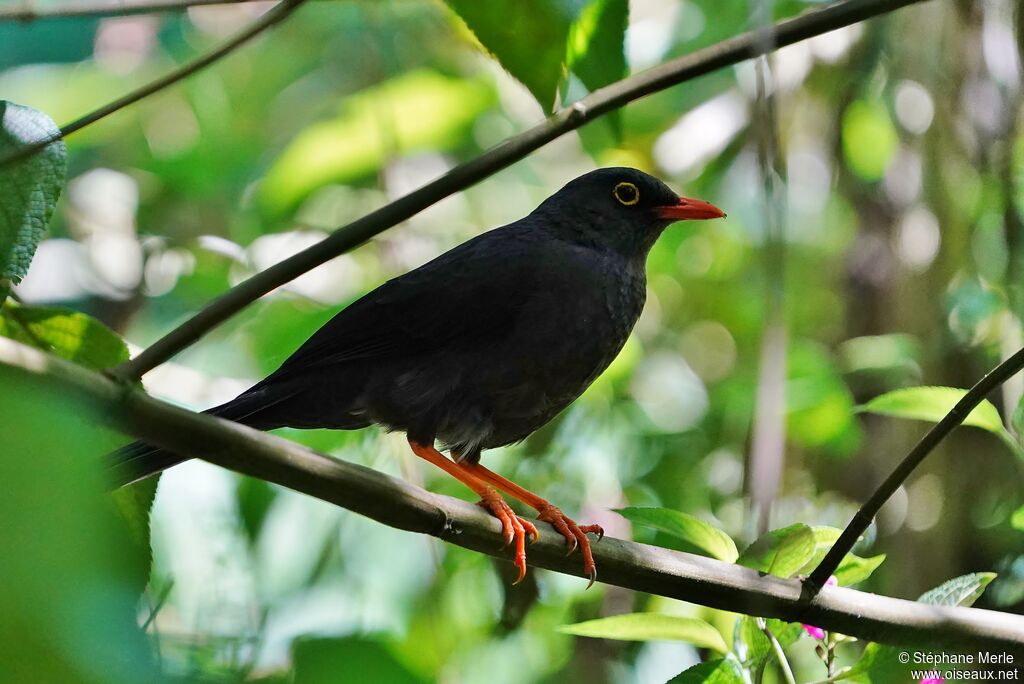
[{"xmin": 445, "ymin": 0, "xmax": 582, "ymax": 112}]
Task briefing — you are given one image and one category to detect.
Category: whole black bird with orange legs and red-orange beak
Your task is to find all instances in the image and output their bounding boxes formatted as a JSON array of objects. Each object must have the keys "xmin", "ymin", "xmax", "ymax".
[{"xmin": 114, "ymin": 168, "xmax": 725, "ymax": 583}]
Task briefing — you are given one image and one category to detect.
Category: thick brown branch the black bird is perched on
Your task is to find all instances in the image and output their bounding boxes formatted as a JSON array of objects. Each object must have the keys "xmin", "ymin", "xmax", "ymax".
[{"xmin": 0, "ymin": 338, "xmax": 1024, "ymax": 653}]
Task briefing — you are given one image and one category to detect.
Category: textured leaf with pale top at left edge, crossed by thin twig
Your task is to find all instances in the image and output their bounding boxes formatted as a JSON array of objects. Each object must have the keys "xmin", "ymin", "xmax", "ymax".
[{"xmin": 0, "ymin": 100, "xmax": 68, "ymax": 290}]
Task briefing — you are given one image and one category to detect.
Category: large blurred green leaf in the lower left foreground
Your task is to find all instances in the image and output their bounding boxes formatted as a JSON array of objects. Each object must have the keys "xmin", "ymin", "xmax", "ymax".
[{"xmin": 0, "ymin": 365, "xmax": 156, "ymax": 684}]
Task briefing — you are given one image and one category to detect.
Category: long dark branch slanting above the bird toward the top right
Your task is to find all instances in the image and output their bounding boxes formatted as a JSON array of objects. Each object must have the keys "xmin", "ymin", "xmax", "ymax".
[{"xmin": 113, "ymin": 0, "xmax": 937, "ymax": 380}]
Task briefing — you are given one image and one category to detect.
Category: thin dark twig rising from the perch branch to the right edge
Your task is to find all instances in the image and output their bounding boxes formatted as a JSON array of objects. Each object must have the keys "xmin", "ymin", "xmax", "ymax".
[{"xmin": 804, "ymin": 349, "xmax": 1024, "ymax": 601}]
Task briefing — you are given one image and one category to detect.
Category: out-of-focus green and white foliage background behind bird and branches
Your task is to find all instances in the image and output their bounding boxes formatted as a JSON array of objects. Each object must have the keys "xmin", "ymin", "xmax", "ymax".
[{"xmin": 0, "ymin": 0, "xmax": 1024, "ymax": 684}]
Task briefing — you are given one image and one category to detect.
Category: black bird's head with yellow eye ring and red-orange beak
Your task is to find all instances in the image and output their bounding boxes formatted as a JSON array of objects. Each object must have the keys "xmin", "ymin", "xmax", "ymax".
[{"xmin": 537, "ymin": 167, "xmax": 725, "ymax": 256}]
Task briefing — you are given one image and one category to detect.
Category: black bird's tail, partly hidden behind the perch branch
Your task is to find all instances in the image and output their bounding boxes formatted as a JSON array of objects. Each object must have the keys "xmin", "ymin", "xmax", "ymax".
[{"xmin": 108, "ymin": 386, "xmax": 288, "ymax": 487}]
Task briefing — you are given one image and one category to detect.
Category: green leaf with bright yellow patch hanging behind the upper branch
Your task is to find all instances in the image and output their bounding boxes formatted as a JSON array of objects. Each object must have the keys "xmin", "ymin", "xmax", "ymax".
[{"xmin": 566, "ymin": 0, "xmax": 630, "ymax": 138}]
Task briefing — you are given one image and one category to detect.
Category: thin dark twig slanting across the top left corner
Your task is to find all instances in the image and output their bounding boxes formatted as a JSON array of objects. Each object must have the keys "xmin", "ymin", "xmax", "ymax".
[{"xmin": 0, "ymin": 0, "xmax": 305, "ymax": 167}]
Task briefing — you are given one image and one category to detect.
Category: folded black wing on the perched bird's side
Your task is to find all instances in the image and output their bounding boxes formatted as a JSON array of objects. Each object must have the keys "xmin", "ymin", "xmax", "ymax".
[{"xmin": 268, "ymin": 226, "xmax": 538, "ymax": 380}]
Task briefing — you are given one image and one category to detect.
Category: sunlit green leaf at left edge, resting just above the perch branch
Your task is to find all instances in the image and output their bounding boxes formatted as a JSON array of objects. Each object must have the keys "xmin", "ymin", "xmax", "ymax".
[{"xmin": 0, "ymin": 302, "xmax": 128, "ymax": 370}]
